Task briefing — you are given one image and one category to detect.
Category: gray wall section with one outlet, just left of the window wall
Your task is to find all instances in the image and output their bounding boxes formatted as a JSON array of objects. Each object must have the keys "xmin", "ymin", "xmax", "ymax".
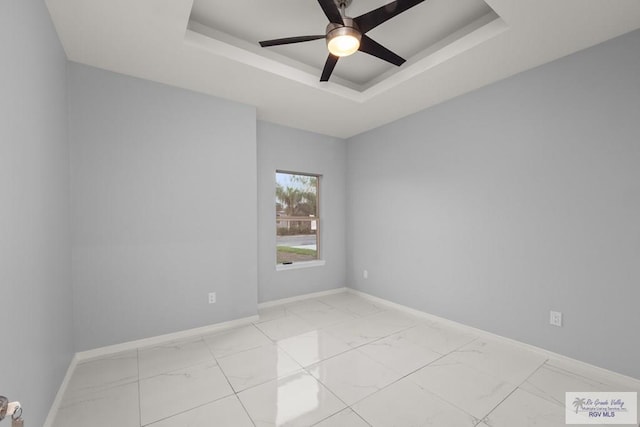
[{"xmin": 69, "ymin": 64, "xmax": 258, "ymax": 350}]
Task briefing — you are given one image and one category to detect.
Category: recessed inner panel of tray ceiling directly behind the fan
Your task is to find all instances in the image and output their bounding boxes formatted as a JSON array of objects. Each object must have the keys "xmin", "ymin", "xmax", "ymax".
[{"xmin": 191, "ymin": 0, "xmax": 497, "ymax": 86}]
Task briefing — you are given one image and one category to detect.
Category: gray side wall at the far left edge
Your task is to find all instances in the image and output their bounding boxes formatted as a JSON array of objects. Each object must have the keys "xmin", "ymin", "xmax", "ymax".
[{"xmin": 0, "ymin": 0, "xmax": 73, "ymax": 426}]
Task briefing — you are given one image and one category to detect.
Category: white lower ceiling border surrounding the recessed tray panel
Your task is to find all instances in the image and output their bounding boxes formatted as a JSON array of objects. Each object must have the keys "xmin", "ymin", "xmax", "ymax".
[{"xmin": 45, "ymin": 0, "xmax": 640, "ymax": 138}]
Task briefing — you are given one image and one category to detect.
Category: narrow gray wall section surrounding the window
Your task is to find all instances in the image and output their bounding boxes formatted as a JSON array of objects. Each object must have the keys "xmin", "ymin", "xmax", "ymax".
[{"xmin": 258, "ymin": 122, "xmax": 346, "ymax": 302}]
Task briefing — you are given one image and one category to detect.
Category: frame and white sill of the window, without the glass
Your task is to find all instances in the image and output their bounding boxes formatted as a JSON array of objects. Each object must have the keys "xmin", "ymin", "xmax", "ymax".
[{"xmin": 274, "ymin": 169, "xmax": 325, "ymax": 271}]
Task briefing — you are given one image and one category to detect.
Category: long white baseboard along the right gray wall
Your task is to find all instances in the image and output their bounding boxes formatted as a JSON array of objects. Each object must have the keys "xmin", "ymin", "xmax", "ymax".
[{"xmin": 347, "ymin": 288, "xmax": 640, "ymax": 390}]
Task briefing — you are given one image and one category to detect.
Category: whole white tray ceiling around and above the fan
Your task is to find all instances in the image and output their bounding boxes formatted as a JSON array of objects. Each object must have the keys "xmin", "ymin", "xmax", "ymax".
[{"xmin": 46, "ymin": 0, "xmax": 640, "ymax": 138}]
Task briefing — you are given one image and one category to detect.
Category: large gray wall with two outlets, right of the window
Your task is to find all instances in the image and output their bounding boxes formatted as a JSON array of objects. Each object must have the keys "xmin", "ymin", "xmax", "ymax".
[{"xmin": 348, "ymin": 31, "xmax": 640, "ymax": 378}]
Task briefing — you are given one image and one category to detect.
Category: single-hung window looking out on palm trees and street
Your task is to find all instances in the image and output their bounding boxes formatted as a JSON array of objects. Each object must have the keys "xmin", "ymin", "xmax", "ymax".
[{"xmin": 276, "ymin": 171, "xmax": 320, "ymax": 265}]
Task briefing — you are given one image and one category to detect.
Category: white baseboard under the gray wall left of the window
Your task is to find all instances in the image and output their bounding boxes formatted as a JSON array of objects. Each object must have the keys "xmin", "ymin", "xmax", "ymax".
[{"xmin": 76, "ymin": 315, "xmax": 258, "ymax": 362}]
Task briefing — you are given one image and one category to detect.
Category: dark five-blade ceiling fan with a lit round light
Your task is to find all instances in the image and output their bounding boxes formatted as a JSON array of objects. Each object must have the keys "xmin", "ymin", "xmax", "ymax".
[{"xmin": 260, "ymin": 0, "xmax": 424, "ymax": 82}]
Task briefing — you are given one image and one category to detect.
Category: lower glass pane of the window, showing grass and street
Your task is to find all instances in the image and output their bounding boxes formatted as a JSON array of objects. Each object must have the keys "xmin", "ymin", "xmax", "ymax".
[{"xmin": 276, "ymin": 220, "xmax": 318, "ymax": 264}]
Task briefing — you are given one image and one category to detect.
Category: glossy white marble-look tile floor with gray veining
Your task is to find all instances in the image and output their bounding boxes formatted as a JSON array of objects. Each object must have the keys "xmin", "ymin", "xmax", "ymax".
[{"xmin": 54, "ymin": 293, "xmax": 640, "ymax": 427}]
